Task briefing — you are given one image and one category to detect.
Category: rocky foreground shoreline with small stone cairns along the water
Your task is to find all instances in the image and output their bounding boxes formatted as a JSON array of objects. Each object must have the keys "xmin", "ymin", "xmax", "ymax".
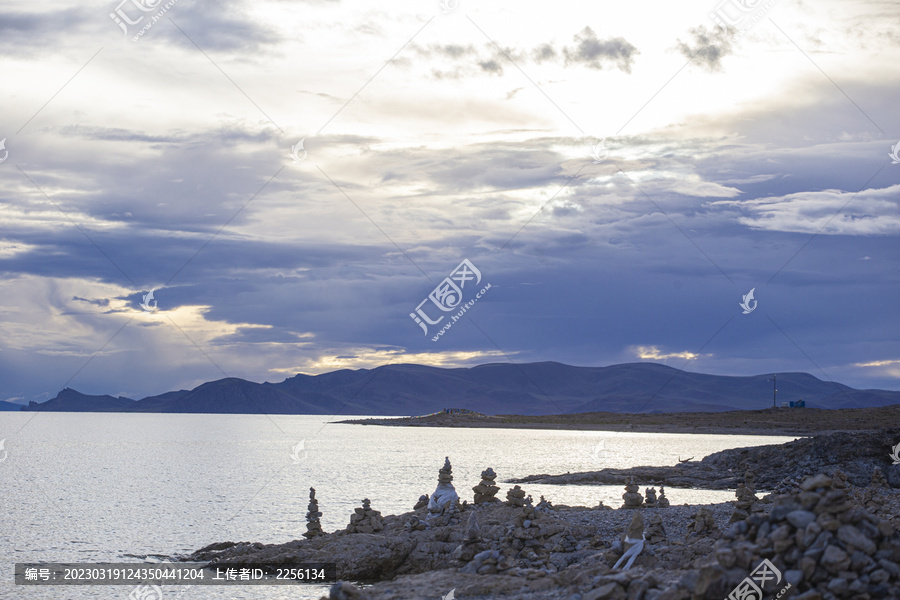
[{"xmin": 181, "ymin": 430, "xmax": 900, "ymax": 600}]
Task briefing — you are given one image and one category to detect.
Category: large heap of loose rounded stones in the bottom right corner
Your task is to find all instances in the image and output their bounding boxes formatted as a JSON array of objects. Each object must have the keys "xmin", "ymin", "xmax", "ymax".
[{"xmin": 716, "ymin": 474, "xmax": 900, "ymax": 599}]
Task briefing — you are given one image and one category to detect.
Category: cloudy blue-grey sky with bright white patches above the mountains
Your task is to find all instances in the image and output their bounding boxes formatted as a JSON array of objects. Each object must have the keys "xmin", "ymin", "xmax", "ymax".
[{"xmin": 0, "ymin": 0, "xmax": 900, "ymax": 403}]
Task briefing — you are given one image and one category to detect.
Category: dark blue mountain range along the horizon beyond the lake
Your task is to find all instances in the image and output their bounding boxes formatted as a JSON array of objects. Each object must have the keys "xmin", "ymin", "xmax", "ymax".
[{"xmin": 22, "ymin": 362, "xmax": 900, "ymax": 416}]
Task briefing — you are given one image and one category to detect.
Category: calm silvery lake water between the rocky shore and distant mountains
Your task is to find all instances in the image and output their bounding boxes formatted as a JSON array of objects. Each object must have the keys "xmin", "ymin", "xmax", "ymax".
[{"xmin": 0, "ymin": 413, "xmax": 794, "ymax": 600}]
